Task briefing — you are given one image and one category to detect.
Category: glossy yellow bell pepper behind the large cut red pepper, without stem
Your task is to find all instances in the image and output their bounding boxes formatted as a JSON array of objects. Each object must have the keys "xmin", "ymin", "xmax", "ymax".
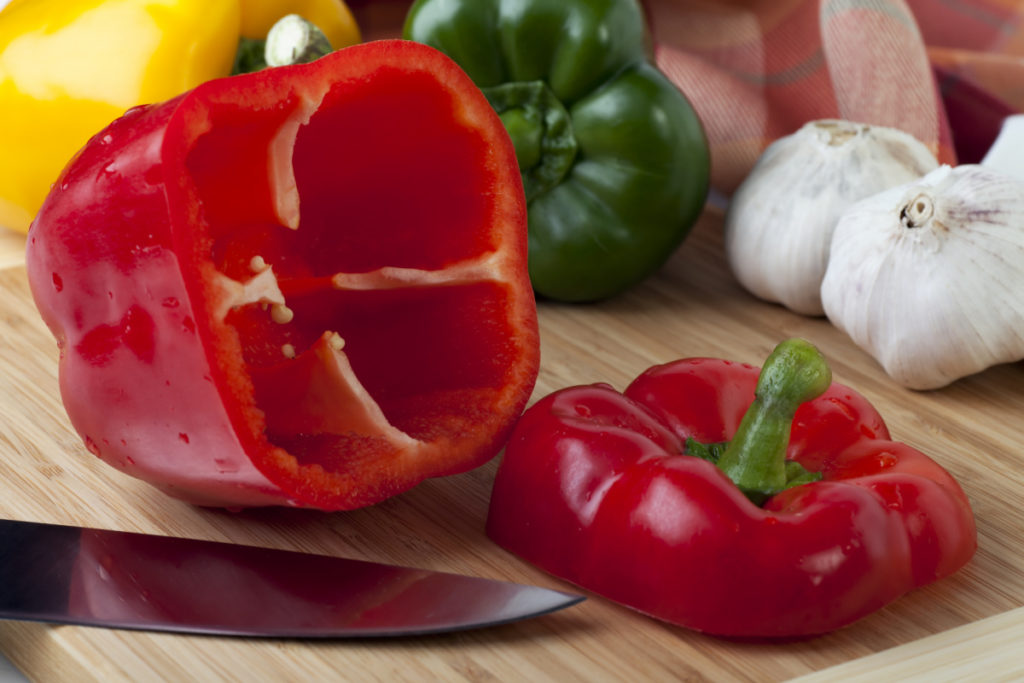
[{"xmin": 0, "ymin": 0, "xmax": 359, "ymax": 232}]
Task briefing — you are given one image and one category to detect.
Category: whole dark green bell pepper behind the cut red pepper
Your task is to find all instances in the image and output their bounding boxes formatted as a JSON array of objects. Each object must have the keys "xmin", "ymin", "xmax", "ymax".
[{"xmin": 403, "ymin": 0, "xmax": 710, "ymax": 301}]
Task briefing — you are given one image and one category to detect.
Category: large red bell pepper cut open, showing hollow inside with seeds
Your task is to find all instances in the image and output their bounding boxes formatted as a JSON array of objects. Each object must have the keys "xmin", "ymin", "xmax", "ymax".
[{"xmin": 28, "ymin": 41, "xmax": 539, "ymax": 509}]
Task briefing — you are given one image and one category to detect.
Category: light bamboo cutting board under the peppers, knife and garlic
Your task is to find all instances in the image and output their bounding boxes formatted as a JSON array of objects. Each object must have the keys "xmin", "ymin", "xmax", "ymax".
[{"xmin": 0, "ymin": 208, "xmax": 1024, "ymax": 681}]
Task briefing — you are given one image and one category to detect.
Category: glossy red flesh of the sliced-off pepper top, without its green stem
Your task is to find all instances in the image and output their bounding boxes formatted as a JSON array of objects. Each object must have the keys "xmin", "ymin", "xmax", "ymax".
[{"xmin": 487, "ymin": 358, "xmax": 977, "ymax": 637}]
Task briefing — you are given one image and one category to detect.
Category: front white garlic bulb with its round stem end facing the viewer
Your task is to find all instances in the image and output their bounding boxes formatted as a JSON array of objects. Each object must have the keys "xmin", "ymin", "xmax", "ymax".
[{"xmin": 821, "ymin": 165, "xmax": 1024, "ymax": 389}]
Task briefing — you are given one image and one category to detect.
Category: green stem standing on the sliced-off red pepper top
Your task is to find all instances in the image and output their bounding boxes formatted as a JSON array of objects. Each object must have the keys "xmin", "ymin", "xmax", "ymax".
[{"xmin": 718, "ymin": 339, "xmax": 831, "ymax": 505}]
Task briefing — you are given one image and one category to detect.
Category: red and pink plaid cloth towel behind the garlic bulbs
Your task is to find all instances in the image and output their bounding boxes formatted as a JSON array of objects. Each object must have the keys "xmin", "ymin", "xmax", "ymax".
[{"xmin": 645, "ymin": 0, "xmax": 1024, "ymax": 194}]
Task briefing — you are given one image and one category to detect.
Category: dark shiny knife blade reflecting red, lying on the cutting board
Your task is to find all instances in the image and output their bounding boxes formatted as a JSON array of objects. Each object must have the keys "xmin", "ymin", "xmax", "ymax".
[{"xmin": 0, "ymin": 520, "xmax": 584, "ymax": 638}]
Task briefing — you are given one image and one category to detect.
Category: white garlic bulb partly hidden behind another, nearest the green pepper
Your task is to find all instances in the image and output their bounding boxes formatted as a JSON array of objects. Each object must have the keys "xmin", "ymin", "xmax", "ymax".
[{"xmin": 725, "ymin": 120, "xmax": 939, "ymax": 315}]
